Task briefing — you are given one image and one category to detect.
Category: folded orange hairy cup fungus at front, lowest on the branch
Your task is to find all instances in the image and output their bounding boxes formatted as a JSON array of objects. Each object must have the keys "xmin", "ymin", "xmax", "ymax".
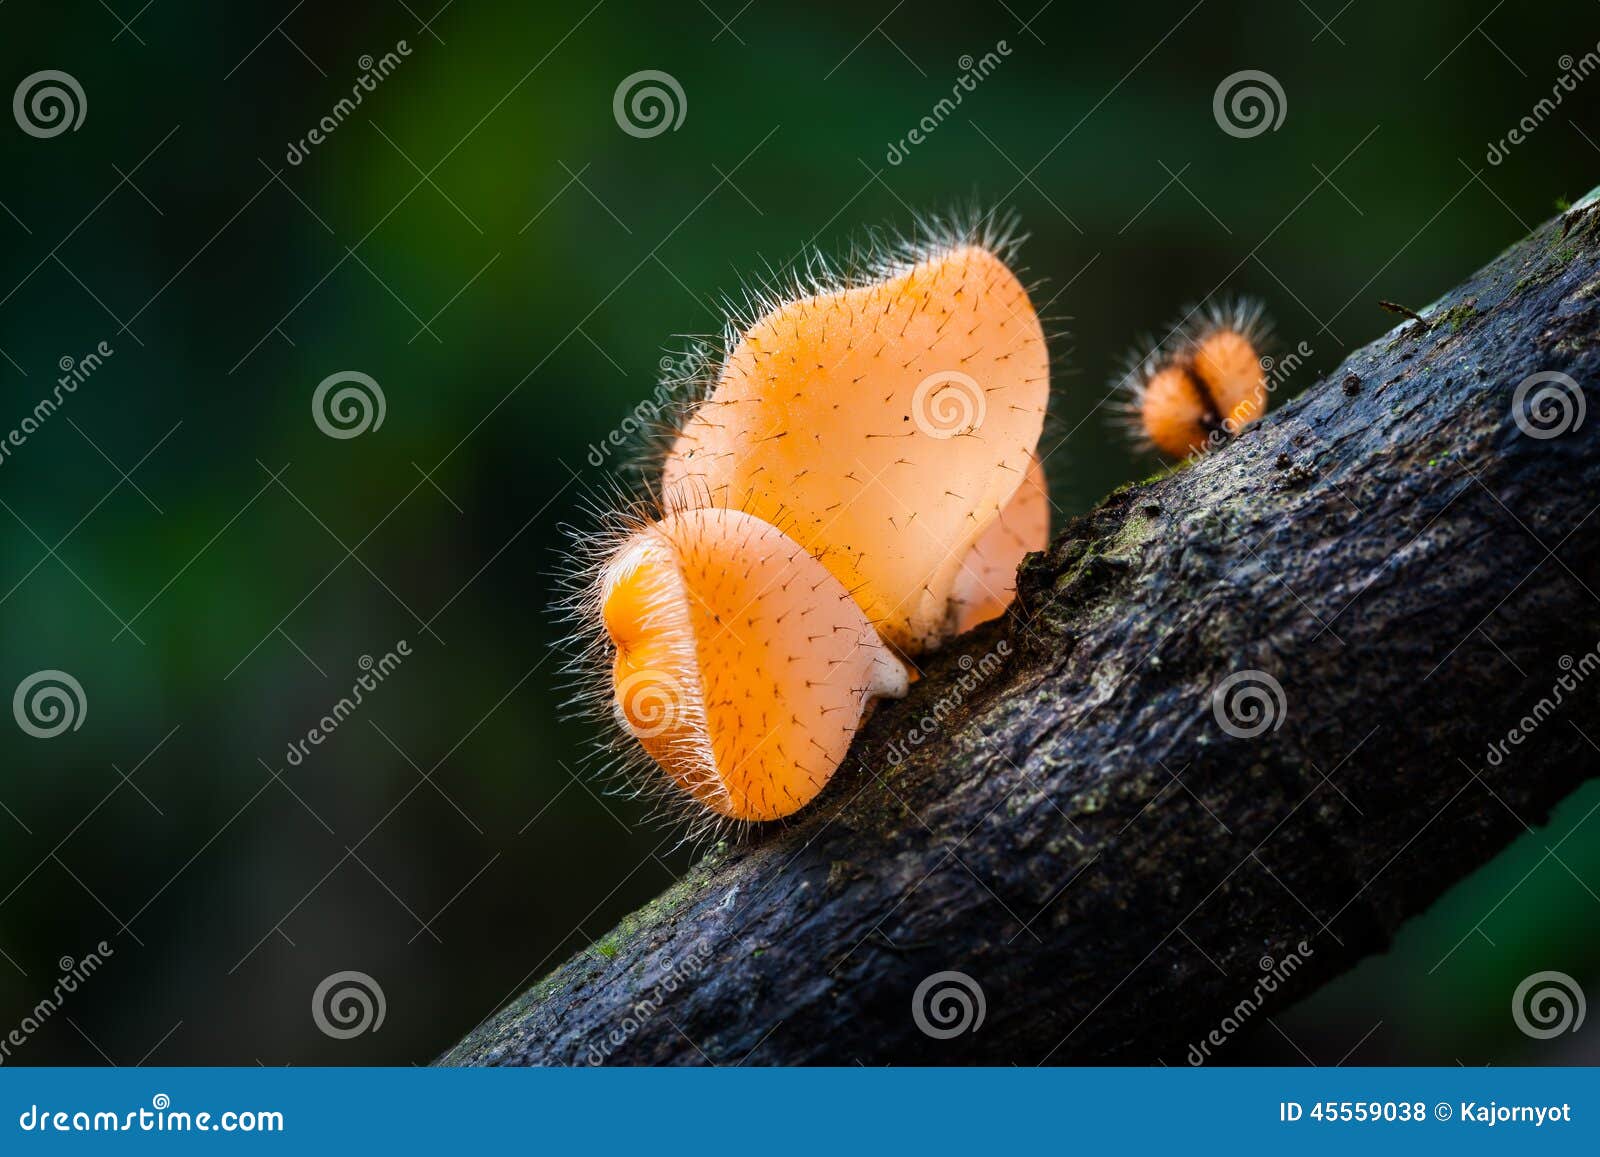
[{"xmin": 598, "ymin": 507, "xmax": 909, "ymax": 821}]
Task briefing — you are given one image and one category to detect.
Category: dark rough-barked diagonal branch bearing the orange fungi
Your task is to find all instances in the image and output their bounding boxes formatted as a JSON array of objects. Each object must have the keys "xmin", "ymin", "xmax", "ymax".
[{"xmin": 443, "ymin": 206, "xmax": 1600, "ymax": 1064}]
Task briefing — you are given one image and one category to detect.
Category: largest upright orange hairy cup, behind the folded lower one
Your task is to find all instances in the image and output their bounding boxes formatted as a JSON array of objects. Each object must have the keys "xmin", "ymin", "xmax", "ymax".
[{"xmin": 662, "ymin": 243, "xmax": 1050, "ymax": 655}]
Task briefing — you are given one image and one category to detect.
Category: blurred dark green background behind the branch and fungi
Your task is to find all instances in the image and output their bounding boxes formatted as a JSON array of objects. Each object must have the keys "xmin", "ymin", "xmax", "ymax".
[{"xmin": 0, "ymin": 0, "xmax": 1600, "ymax": 1064}]
